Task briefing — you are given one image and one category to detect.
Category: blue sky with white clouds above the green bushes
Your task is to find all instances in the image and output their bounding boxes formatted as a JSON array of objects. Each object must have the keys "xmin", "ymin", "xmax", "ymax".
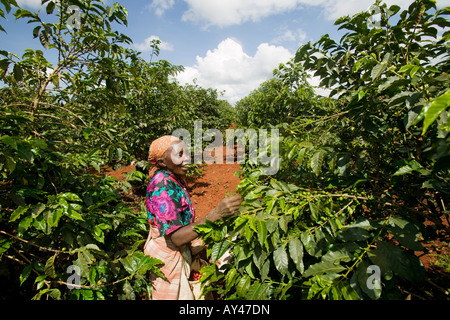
[{"xmin": 0, "ymin": 0, "xmax": 450, "ymax": 105}]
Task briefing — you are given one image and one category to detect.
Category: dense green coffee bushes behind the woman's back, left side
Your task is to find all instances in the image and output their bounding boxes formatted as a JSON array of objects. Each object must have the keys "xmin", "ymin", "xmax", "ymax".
[{"xmin": 0, "ymin": 0, "xmax": 233, "ymax": 299}]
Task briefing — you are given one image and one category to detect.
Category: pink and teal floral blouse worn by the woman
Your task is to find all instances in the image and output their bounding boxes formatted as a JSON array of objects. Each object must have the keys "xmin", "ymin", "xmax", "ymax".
[{"xmin": 146, "ymin": 170, "xmax": 195, "ymax": 236}]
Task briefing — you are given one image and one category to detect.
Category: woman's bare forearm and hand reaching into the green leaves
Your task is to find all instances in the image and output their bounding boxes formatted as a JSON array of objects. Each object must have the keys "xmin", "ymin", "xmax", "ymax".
[{"xmin": 170, "ymin": 195, "xmax": 243, "ymax": 247}]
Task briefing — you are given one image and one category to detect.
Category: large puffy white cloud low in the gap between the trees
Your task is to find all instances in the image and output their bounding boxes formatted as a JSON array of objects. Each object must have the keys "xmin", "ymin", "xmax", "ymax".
[{"xmin": 177, "ymin": 38, "xmax": 293, "ymax": 104}]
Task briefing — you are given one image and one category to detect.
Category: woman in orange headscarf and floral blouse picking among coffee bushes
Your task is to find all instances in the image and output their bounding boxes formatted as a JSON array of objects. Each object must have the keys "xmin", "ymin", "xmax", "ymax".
[{"xmin": 144, "ymin": 136, "xmax": 242, "ymax": 300}]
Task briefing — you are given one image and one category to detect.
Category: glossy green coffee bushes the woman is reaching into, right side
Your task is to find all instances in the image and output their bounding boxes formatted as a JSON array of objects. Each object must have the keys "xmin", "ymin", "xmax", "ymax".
[{"xmin": 197, "ymin": 0, "xmax": 450, "ymax": 299}]
